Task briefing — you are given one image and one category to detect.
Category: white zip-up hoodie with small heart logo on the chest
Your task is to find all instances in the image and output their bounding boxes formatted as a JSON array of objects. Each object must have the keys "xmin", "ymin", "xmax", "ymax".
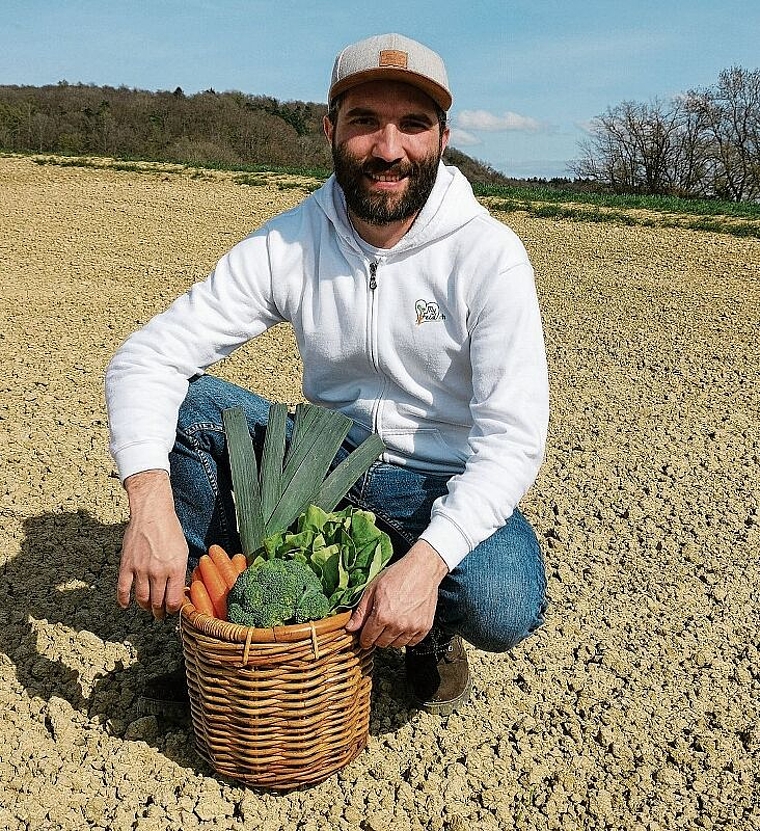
[{"xmin": 106, "ymin": 164, "xmax": 548, "ymax": 569}]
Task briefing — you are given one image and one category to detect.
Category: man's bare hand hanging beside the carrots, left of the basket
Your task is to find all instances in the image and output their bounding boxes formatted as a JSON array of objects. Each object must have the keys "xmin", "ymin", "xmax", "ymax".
[{"xmin": 117, "ymin": 470, "xmax": 188, "ymax": 620}]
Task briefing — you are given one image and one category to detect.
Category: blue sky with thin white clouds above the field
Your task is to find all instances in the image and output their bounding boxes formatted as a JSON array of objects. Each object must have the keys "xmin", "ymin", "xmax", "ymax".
[{"xmin": 0, "ymin": 0, "xmax": 760, "ymax": 177}]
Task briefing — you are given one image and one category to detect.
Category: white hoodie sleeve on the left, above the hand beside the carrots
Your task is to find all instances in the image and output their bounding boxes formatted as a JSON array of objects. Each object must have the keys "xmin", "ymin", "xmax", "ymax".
[{"xmin": 105, "ymin": 234, "xmax": 283, "ymax": 482}]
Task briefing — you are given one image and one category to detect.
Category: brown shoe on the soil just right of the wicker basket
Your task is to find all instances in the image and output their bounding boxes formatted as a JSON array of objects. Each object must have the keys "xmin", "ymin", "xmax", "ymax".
[{"xmin": 404, "ymin": 627, "xmax": 470, "ymax": 716}]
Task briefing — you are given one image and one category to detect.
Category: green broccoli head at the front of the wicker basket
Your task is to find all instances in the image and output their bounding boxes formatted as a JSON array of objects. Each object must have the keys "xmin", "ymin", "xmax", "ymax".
[{"xmin": 227, "ymin": 560, "xmax": 330, "ymax": 628}]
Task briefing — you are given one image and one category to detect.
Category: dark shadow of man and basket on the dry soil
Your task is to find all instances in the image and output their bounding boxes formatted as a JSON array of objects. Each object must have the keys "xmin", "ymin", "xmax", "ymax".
[{"xmin": 0, "ymin": 511, "xmax": 413, "ymax": 775}]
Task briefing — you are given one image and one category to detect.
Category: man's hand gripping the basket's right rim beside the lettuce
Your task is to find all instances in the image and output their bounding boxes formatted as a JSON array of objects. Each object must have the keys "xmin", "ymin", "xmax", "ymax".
[{"xmin": 346, "ymin": 540, "xmax": 448, "ymax": 649}]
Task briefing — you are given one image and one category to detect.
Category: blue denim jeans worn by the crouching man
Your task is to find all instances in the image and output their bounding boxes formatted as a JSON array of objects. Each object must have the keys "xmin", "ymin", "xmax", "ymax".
[{"xmin": 170, "ymin": 375, "xmax": 546, "ymax": 652}]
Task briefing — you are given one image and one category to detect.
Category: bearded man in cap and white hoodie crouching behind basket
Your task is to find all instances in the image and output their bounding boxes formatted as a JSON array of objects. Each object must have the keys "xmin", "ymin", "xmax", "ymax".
[{"xmin": 106, "ymin": 34, "xmax": 548, "ymax": 714}]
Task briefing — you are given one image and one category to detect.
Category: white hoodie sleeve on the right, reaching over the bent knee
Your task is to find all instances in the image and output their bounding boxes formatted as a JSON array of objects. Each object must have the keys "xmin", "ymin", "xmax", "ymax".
[{"xmin": 421, "ymin": 257, "xmax": 549, "ymax": 569}]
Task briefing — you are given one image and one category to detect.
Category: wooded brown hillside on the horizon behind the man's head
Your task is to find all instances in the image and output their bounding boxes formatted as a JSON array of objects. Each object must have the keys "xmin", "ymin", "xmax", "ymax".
[{"xmin": 0, "ymin": 81, "xmax": 508, "ymax": 184}]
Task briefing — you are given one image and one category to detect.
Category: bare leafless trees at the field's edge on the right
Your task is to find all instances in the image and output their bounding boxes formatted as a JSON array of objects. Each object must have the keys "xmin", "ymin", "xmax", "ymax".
[{"xmin": 571, "ymin": 66, "xmax": 760, "ymax": 202}]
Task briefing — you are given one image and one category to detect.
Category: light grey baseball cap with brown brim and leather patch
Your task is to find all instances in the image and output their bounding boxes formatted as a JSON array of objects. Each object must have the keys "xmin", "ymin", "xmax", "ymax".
[{"xmin": 327, "ymin": 34, "xmax": 452, "ymax": 110}]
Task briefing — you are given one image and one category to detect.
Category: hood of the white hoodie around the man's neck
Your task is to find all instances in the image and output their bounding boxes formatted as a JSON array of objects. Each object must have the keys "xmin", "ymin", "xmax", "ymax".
[{"xmin": 313, "ymin": 162, "xmax": 488, "ymax": 253}]
